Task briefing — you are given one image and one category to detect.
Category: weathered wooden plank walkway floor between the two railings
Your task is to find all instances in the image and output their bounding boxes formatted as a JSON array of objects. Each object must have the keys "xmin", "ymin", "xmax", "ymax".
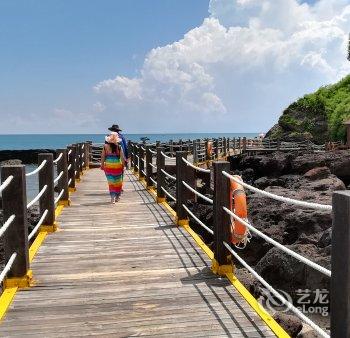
[{"xmin": 0, "ymin": 169, "xmax": 274, "ymax": 337}]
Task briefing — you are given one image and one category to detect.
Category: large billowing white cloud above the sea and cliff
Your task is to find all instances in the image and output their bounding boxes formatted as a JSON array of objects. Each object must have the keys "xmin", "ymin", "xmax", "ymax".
[{"xmin": 94, "ymin": 0, "xmax": 350, "ymax": 132}]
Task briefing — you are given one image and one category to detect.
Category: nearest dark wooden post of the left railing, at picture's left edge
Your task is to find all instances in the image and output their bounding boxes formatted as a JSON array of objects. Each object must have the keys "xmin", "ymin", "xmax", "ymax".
[{"xmin": 1, "ymin": 165, "xmax": 30, "ymax": 287}]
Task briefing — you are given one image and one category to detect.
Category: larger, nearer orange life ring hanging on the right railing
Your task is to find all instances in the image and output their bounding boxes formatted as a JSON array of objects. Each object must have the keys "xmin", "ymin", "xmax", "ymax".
[{"xmin": 230, "ymin": 175, "xmax": 248, "ymax": 245}]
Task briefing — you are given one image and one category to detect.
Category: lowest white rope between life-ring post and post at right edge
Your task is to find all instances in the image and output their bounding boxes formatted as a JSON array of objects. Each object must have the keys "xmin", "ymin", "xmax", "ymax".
[{"xmin": 223, "ymin": 242, "xmax": 330, "ymax": 338}]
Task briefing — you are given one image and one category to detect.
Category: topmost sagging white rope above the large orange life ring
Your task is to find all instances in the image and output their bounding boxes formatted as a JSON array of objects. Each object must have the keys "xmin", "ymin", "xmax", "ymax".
[{"xmin": 222, "ymin": 171, "xmax": 332, "ymax": 211}]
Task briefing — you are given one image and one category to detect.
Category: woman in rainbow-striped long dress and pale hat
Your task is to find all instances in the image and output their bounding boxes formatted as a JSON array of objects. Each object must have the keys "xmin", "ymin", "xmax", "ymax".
[{"xmin": 101, "ymin": 136, "xmax": 124, "ymax": 204}]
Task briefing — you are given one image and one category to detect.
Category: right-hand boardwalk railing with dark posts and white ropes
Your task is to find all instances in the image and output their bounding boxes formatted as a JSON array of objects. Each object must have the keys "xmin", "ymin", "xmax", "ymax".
[{"xmin": 129, "ymin": 141, "xmax": 350, "ymax": 337}]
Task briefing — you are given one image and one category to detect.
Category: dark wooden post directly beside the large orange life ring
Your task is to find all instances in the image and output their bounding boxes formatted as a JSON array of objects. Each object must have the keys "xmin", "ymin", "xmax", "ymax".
[{"xmin": 212, "ymin": 161, "xmax": 232, "ymax": 275}]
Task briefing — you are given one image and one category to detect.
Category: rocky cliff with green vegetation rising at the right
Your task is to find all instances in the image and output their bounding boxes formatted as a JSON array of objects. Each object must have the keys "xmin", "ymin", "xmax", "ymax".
[{"xmin": 266, "ymin": 75, "xmax": 350, "ymax": 144}]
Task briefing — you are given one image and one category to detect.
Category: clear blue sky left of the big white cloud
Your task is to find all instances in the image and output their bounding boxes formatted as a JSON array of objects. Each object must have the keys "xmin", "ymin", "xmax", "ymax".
[{"xmin": 0, "ymin": 0, "xmax": 208, "ymax": 133}]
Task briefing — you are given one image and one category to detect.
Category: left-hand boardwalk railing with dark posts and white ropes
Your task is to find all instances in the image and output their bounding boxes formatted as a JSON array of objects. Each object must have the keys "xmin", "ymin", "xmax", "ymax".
[{"xmin": 0, "ymin": 142, "xmax": 90, "ymax": 296}]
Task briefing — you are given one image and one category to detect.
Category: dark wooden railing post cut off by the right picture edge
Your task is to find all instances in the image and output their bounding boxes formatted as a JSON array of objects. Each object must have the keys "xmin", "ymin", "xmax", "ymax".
[{"xmin": 330, "ymin": 191, "xmax": 350, "ymax": 338}]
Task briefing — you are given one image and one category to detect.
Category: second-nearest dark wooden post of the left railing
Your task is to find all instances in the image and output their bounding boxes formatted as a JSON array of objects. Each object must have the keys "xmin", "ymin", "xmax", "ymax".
[{"xmin": 38, "ymin": 154, "xmax": 56, "ymax": 231}]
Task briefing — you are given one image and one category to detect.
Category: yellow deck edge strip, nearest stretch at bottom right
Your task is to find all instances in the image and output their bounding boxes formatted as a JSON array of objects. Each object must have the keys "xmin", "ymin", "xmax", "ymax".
[{"xmin": 226, "ymin": 273, "xmax": 290, "ymax": 338}]
